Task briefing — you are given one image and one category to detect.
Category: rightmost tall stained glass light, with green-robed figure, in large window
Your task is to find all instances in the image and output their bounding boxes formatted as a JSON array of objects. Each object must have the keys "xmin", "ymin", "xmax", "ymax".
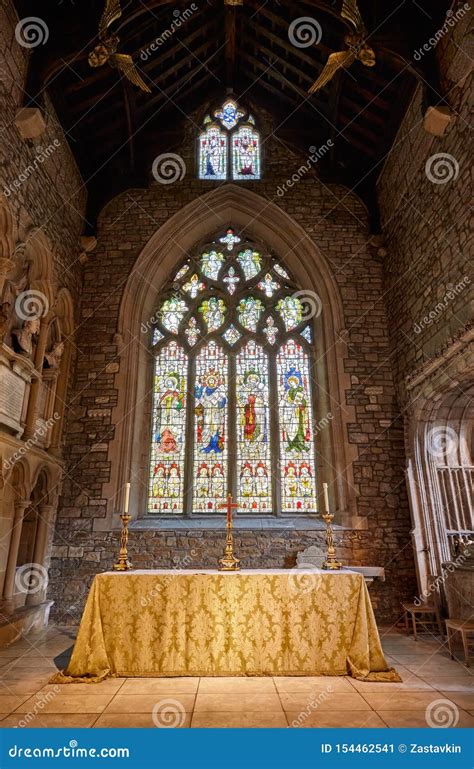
[{"xmin": 277, "ymin": 339, "xmax": 316, "ymax": 513}]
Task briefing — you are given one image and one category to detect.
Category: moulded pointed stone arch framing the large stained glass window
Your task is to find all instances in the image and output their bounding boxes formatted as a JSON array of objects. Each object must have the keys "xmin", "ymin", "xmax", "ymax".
[{"xmin": 102, "ymin": 184, "xmax": 356, "ymax": 529}]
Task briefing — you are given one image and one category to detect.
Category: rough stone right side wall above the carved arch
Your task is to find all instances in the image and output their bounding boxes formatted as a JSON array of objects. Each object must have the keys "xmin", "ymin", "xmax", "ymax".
[{"xmin": 378, "ymin": 16, "xmax": 474, "ymax": 408}]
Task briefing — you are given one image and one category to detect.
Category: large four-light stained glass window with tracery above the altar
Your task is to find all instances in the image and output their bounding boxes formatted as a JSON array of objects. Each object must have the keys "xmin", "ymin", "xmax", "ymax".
[{"xmin": 148, "ymin": 228, "xmax": 316, "ymax": 515}]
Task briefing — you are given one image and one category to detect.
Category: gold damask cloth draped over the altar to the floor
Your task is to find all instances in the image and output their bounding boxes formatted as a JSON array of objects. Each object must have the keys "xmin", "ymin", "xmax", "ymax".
[{"xmin": 53, "ymin": 569, "xmax": 400, "ymax": 683}]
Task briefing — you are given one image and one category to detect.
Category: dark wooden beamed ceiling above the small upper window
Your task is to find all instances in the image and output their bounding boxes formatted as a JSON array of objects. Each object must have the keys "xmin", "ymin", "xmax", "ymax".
[{"xmin": 16, "ymin": 0, "xmax": 450, "ymax": 228}]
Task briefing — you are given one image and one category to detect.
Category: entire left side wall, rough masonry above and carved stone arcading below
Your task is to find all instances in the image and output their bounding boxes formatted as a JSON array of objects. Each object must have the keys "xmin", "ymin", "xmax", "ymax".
[{"xmin": 0, "ymin": 0, "xmax": 86, "ymax": 612}]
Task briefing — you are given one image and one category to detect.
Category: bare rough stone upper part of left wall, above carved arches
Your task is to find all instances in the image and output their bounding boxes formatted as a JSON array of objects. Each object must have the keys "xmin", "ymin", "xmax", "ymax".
[{"xmin": 0, "ymin": 0, "xmax": 86, "ymax": 296}]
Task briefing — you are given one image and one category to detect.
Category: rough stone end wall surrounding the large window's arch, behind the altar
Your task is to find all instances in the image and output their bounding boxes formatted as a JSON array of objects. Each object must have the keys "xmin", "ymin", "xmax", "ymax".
[{"xmin": 50, "ymin": 109, "xmax": 414, "ymax": 622}]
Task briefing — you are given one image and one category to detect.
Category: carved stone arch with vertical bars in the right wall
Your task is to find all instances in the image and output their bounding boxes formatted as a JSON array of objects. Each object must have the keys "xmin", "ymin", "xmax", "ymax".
[{"xmin": 406, "ymin": 332, "xmax": 474, "ymax": 589}]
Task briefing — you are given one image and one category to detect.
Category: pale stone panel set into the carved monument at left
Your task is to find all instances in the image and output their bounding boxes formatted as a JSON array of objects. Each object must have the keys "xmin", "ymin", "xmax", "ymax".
[{"xmin": 0, "ymin": 343, "xmax": 35, "ymax": 438}]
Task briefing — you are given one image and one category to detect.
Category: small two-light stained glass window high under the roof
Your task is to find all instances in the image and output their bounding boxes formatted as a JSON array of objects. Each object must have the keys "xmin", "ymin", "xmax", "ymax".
[{"xmin": 199, "ymin": 99, "xmax": 261, "ymax": 181}]
